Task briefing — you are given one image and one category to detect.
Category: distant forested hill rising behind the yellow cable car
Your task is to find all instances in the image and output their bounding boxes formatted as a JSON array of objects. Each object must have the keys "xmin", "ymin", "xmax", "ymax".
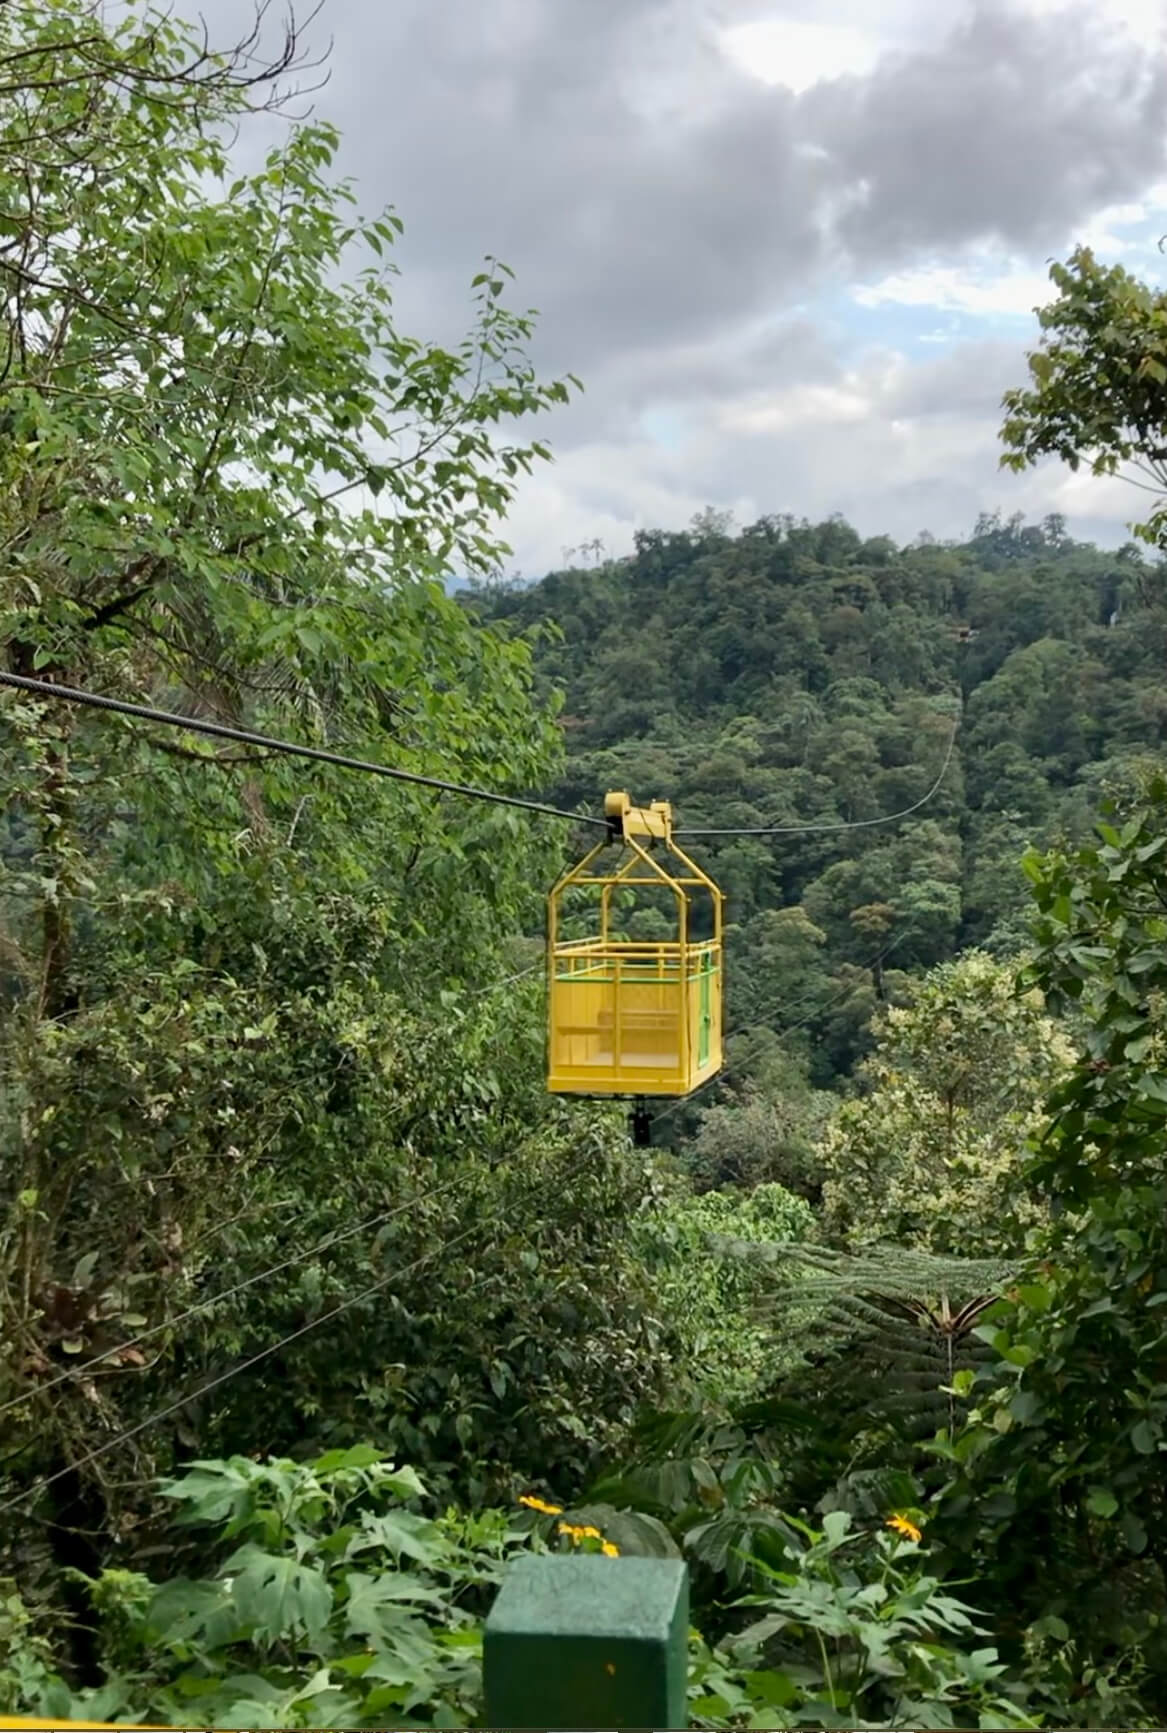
[{"xmin": 470, "ymin": 513, "xmax": 1167, "ymax": 1122}]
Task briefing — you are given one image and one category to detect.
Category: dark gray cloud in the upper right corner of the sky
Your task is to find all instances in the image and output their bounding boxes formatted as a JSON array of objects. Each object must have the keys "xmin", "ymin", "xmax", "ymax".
[{"xmin": 806, "ymin": 0, "xmax": 1167, "ymax": 267}]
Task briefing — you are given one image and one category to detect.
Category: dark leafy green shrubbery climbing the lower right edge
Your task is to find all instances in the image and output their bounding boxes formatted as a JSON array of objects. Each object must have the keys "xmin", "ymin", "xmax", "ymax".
[{"xmin": 949, "ymin": 780, "xmax": 1167, "ymax": 1690}]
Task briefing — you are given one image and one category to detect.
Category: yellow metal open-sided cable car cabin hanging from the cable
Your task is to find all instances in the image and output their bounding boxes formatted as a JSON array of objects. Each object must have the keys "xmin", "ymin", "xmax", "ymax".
[{"xmin": 548, "ymin": 794, "xmax": 723, "ymax": 1097}]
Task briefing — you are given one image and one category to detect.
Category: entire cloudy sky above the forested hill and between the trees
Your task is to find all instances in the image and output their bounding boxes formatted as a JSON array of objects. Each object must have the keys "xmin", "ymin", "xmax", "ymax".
[{"xmin": 215, "ymin": 0, "xmax": 1167, "ymax": 575}]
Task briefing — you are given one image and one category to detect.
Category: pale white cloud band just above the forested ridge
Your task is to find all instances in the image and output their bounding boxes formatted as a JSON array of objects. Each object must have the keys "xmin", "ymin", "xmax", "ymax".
[{"xmin": 510, "ymin": 341, "xmax": 1144, "ymax": 574}]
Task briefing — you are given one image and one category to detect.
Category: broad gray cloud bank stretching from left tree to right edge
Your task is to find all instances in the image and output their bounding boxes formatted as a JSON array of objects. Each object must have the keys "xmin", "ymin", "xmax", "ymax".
[{"xmin": 182, "ymin": 0, "xmax": 1167, "ymax": 373}]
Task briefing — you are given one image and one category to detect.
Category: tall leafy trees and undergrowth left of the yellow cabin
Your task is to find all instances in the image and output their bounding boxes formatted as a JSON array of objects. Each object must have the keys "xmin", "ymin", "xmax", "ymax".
[{"xmin": 0, "ymin": 0, "xmax": 671, "ymax": 1608}]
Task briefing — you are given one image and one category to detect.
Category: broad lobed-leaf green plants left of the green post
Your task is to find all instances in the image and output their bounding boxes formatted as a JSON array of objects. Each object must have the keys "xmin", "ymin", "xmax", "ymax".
[{"xmin": 4, "ymin": 1445, "xmax": 531, "ymax": 1728}]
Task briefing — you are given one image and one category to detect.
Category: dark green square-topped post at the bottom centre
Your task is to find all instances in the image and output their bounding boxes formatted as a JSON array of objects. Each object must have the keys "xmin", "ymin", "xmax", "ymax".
[{"xmin": 482, "ymin": 1553, "xmax": 688, "ymax": 1733}]
